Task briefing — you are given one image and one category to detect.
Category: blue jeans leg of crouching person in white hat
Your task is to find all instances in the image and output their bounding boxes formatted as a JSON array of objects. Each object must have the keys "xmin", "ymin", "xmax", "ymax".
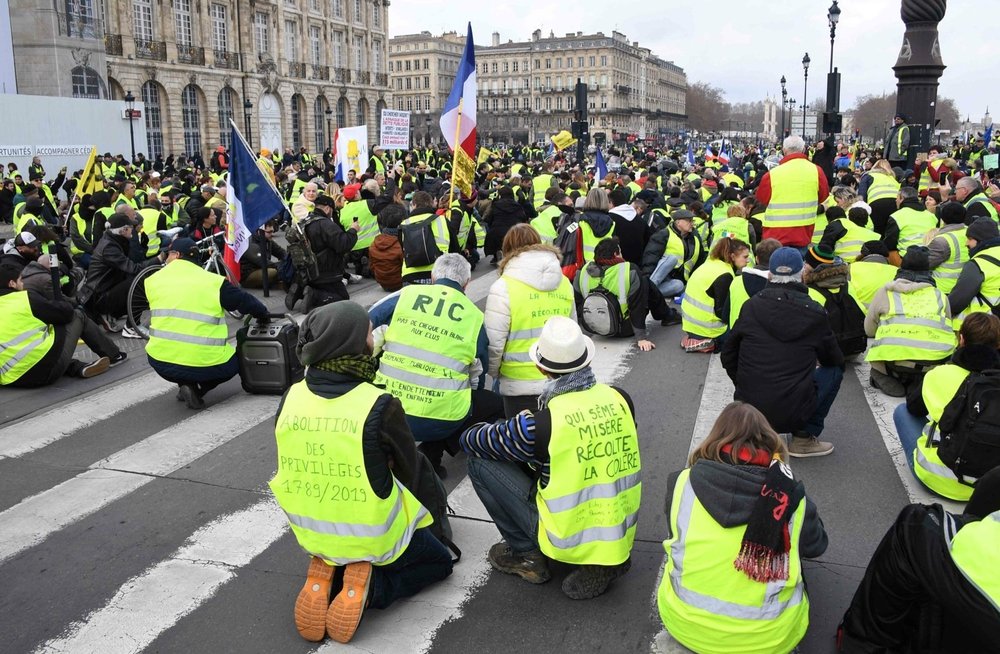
[{"xmin": 469, "ymin": 457, "xmax": 538, "ymax": 554}]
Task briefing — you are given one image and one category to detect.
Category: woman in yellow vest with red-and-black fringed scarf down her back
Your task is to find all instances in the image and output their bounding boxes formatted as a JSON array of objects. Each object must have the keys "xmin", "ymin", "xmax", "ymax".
[{"xmin": 657, "ymin": 402, "xmax": 828, "ymax": 654}]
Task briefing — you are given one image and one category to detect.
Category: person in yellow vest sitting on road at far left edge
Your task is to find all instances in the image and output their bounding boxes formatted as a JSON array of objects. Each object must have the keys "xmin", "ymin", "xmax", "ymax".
[{"xmin": 0, "ymin": 263, "xmax": 126, "ymax": 388}]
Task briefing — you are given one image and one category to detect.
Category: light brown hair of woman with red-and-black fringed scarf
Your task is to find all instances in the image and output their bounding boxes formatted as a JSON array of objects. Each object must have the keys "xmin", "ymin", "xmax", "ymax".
[{"xmin": 688, "ymin": 402, "xmax": 788, "ymax": 465}]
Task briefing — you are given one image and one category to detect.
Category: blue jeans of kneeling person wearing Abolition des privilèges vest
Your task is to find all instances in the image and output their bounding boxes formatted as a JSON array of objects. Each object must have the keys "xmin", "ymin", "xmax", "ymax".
[{"xmin": 369, "ymin": 527, "xmax": 452, "ymax": 609}]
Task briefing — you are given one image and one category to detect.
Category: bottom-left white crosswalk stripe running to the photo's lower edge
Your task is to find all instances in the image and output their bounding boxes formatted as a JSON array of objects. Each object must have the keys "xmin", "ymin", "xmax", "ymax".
[{"xmin": 36, "ymin": 499, "xmax": 291, "ymax": 654}]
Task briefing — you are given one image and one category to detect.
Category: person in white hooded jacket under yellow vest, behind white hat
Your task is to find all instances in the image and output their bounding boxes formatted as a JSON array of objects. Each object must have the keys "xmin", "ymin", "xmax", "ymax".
[{"xmin": 485, "ymin": 225, "xmax": 577, "ymax": 418}]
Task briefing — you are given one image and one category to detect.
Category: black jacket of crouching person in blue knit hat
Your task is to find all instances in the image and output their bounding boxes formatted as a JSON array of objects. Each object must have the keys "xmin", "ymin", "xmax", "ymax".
[{"xmin": 721, "ymin": 282, "xmax": 844, "ymax": 432}]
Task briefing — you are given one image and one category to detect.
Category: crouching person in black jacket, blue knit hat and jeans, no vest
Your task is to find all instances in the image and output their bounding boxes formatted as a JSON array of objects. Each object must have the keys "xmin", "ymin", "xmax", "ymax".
[{"xmin": 721, "ymin": 247, "xmax": 844, "ymax": 457}]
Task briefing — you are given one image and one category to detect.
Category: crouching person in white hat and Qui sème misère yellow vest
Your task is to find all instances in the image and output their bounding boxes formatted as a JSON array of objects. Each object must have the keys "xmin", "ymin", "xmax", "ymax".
[{"xmin": 460, "ymin": 316, "xmax": 642, "ymax": 599}]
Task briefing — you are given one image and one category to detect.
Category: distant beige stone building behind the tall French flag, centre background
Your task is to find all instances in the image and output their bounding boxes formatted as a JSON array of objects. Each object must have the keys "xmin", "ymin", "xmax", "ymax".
[{"xmin": 390, "ymin": 30, "xmax": 687, "ymax": 144}]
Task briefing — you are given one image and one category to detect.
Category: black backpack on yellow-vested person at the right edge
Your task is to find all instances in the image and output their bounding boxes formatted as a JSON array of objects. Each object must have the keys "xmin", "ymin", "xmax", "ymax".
[{"xmin": 937, "ymin": 370, "xmax": 1000, "ymax": 483}]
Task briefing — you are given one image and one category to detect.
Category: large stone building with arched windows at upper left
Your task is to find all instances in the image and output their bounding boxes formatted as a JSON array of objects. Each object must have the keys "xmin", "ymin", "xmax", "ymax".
[{"xmin": 10, "ymin": 0, "xmax": 391, "ymax": 158}]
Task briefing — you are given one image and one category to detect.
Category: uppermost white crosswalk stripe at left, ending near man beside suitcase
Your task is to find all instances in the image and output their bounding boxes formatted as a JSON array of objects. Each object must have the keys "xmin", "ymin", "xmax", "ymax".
[{"xmin": 0, "ymin": 373, "xmax": 177, "ymax": 457}]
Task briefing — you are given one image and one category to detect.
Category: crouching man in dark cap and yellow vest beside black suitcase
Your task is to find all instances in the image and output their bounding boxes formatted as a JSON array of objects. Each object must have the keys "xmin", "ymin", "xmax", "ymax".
[{"xmin": 143, "ymin": 238, "xmax": 267, "ymax": 409}]
